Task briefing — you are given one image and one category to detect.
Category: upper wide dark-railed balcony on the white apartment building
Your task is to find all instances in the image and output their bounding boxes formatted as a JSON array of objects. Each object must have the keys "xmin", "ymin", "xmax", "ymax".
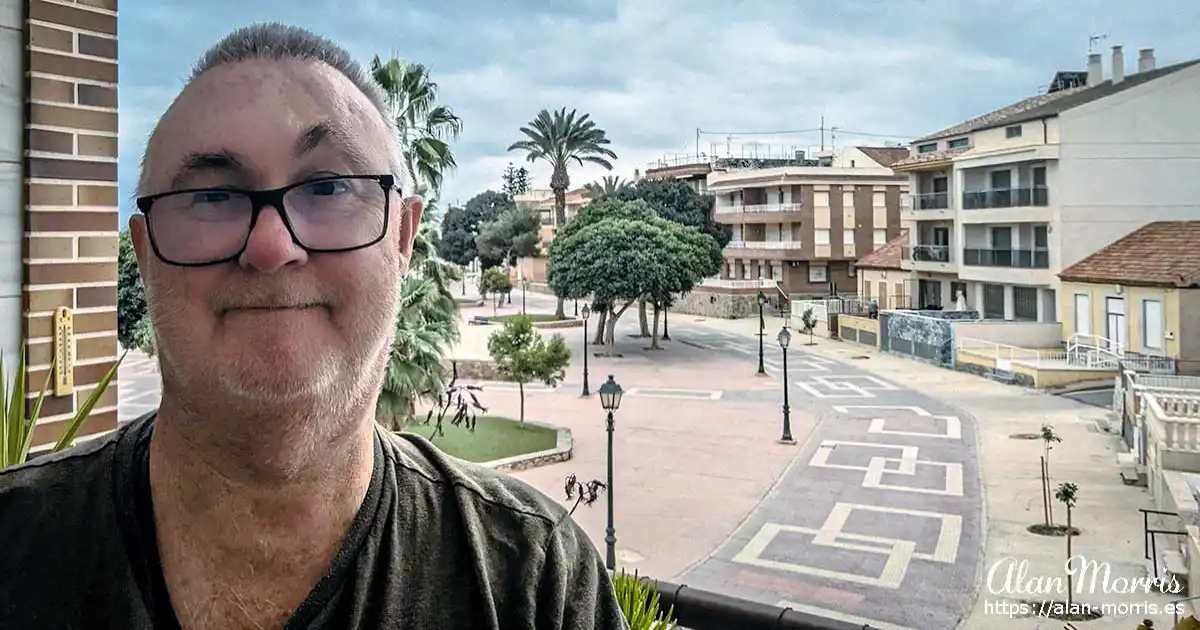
[{"xmin": 959, "ymin": 162, "xmax": 1051, "ymax": 223}]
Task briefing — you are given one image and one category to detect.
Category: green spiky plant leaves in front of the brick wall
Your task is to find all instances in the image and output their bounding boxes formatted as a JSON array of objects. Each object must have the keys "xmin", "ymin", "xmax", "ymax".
[{"xmin": 0, "ymin": 348, "xmax": 125, "ymax": 469}]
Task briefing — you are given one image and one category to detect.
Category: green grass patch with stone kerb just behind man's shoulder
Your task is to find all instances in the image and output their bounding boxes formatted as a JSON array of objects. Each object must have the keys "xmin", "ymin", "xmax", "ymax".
[{"xmin": 403, "ymin": 414, "xmax": 558, "ymax": 462}]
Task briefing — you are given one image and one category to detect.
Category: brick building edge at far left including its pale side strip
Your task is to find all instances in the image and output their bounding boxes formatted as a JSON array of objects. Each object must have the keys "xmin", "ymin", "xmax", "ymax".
[{"xmin": 0, "ymin": 0, "xmax": 118, "ymax": 449}]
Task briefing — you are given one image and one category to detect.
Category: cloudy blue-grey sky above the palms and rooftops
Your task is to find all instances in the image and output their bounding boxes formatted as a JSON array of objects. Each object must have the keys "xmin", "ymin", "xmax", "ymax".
[{"xmin": 119, "ymin": 0, "xmax": 1200, "ymax": 220}]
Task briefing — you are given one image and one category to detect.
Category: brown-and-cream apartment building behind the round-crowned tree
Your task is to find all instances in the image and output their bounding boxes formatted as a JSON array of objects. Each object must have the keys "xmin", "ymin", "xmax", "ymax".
[{"xmin": 683, "ymin": 146, "xmax": 908, "ymax": 317}]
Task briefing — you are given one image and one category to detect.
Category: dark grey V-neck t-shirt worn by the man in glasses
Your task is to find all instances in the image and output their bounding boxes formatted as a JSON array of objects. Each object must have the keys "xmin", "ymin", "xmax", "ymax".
[{"xmin": 0, "ymin": 414, "xmax": 628, "ymax": 630}]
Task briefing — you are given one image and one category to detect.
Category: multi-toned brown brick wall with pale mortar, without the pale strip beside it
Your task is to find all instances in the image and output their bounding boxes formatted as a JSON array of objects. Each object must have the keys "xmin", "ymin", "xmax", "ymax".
[{"xmin": 22, "ymin": 0, "xmax": 119, "ymax": 448}]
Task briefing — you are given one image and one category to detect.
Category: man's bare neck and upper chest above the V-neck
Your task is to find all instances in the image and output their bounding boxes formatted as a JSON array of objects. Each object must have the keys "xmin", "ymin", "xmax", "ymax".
[{"xmin": 150, "ymin": 401, "xmax": 374, "ymax": 629}]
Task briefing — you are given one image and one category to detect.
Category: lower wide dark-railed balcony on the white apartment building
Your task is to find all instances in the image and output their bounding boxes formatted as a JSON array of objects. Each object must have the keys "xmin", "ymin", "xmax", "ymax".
[{"xmin": 959, "ymin": 223, "xmax": 1054, "ymax": 286}]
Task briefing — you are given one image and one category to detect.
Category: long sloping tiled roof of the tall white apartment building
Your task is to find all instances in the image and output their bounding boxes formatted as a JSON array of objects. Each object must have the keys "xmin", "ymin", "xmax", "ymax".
[{"xmin": 913, "ymin": 59, "xmax": 1200, "ymax": 142}]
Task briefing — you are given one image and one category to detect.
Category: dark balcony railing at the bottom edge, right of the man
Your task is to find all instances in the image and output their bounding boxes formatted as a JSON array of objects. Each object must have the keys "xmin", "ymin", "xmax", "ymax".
[{"xmin": 642, "ymin": 577, "xmax": 872, "ymax": 630}]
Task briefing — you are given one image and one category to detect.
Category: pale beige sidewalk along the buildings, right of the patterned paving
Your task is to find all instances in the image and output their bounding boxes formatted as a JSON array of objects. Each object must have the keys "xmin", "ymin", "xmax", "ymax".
[{"xmin": 691, "ymin": 316, "xmax": 1178, "ymax": 630}]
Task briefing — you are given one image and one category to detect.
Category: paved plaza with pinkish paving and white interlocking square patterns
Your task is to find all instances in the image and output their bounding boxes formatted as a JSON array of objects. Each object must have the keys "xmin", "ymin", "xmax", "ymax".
[{"xmin": 121, "ymin": 294, "xmax": 1170, "ymax": 630}]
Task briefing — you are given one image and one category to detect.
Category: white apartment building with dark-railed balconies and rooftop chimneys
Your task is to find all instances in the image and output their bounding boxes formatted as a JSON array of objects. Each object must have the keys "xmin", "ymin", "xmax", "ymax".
[{"xmin": 892, "ymin": 46, "xmax": 1200, "ymax": 322}]
